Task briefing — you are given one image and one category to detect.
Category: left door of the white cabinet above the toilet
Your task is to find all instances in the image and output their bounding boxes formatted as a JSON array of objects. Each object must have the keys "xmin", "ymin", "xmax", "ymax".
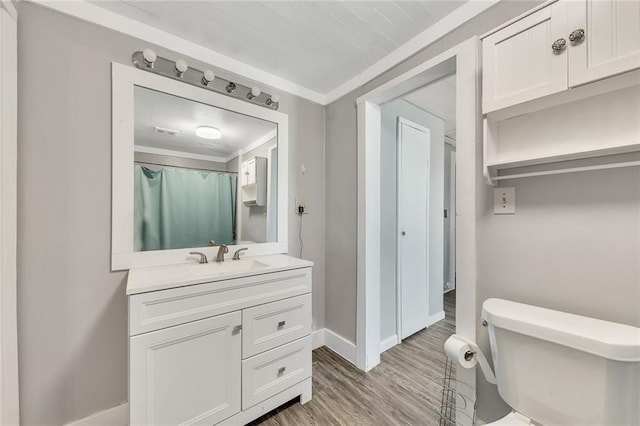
[{"xmin": 482, "ymin": 0, "xmax": 568, "ymax": 113}]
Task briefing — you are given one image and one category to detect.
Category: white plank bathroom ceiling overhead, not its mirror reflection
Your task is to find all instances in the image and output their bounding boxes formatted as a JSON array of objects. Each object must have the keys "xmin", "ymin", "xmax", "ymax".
[{"xmin": 91, "ymin": 0, "xmax": 465, "ymax": 93}]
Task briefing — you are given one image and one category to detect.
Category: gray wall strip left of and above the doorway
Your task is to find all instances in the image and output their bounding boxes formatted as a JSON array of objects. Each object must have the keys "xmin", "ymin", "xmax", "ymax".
[{"xmin": 325, "ymin": 1, "xmax": 542, "ymax": 343}]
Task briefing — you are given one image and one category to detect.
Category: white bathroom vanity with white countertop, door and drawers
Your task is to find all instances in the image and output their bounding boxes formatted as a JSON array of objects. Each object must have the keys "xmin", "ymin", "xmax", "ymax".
[{"xmin": 127, "ymin": 255, "xmax": 312, "ymax": 425}]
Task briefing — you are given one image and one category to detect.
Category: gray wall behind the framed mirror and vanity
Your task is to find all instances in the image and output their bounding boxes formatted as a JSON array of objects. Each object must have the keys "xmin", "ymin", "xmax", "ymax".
[{"xmin": 18, "ymin": 2, "xmax": 325, "ymax": 425}]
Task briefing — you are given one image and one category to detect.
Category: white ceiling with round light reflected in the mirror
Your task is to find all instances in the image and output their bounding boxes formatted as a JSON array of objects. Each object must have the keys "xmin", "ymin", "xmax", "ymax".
[{"xmin": 134, "ymin": 86, "xmax": 277, "ymax": 158}]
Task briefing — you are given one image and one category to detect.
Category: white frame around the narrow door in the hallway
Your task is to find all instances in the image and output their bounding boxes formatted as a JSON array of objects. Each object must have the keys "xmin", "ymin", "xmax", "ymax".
[{"xmin": 396, "ymin": 116, "xmax": 431, "ymax": 343}]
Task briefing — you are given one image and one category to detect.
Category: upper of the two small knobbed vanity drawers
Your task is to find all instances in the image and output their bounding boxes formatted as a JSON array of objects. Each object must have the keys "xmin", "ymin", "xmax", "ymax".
[{"xmin": 242, "ymin": 294, "xmax": 311, "ymax": 358}]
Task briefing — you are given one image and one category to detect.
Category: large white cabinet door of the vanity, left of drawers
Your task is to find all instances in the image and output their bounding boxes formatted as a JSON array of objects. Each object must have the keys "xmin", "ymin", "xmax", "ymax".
[{"xmin": 129, "ymin": 311, "xmax": 242, "ymax": 426}]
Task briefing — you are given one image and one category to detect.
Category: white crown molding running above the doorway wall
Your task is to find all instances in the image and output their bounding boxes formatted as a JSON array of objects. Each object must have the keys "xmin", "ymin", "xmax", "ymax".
[{"xmin": 324, "ymin": 0, "xmax": 500, "ymax": 105}]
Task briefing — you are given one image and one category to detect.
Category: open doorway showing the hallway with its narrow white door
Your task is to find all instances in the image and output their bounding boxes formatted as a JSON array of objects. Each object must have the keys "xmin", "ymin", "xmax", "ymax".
[{"xmin": 380, "ymin": 74, "xmax": 456, "ymax": 353}]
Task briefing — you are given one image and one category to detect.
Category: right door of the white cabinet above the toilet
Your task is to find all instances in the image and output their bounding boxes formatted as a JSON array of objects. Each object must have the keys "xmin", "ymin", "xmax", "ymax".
[{"xmin": 567, "ymin": 0, "xmax": 640, "ymax": 86}]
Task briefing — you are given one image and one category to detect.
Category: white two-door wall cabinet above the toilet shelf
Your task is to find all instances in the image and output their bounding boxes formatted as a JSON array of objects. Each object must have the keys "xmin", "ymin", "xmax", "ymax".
[{"xmin": 482, "ymin": 0, "xmax": 640, "ymax": 113}]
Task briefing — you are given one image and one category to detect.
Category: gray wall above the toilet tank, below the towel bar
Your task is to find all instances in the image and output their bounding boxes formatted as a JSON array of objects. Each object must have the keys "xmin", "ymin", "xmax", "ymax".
[{"xmin": 477, "ymin": 167, "xmax": 640, "ymax": 421}]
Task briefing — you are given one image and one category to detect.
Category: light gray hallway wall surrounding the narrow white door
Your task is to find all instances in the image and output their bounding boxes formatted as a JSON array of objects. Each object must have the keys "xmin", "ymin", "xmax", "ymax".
[{"xmin": 380, "ymin": 99, "xmax": 444, "ymax": 341}]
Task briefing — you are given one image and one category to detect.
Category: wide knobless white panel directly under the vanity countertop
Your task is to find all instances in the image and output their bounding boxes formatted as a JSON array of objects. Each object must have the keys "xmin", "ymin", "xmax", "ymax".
[{"xmin": 129, "ymin": 268, "xmax": 311, "ymax": 336}]
